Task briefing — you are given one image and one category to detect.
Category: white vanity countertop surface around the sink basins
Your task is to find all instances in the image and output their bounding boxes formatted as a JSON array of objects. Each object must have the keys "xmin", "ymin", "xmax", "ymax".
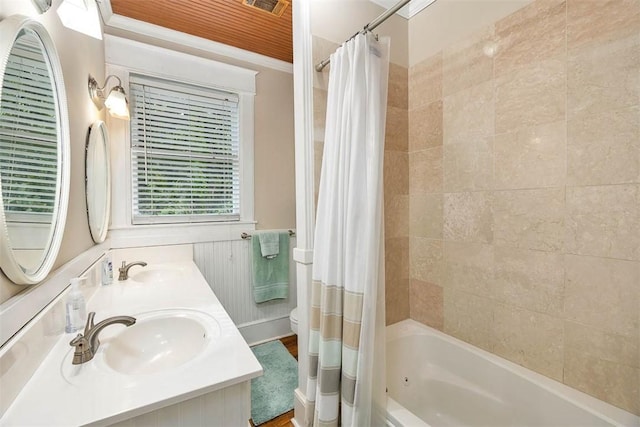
[{"xmin": 1, "ymin": 262, "xmax": 262, "ymax": 426}]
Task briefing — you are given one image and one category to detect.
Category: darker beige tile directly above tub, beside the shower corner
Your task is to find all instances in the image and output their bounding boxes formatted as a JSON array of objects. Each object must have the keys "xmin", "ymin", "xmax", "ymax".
[{"xmin": 409, "ymin": 279, "xmax": 444, "ymax": 330}]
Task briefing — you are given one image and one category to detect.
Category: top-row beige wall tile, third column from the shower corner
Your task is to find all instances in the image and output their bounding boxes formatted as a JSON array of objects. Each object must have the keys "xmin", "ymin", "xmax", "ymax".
[{"xmin": 495, "ymin": 0, "xmax": 566, "ymax": 76}]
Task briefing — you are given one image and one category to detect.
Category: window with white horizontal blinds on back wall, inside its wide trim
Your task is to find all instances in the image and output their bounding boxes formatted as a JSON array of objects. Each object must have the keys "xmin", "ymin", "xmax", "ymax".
[{"xmin": 129, "ymin": 75, "xmax": 240, "ymax": 224}]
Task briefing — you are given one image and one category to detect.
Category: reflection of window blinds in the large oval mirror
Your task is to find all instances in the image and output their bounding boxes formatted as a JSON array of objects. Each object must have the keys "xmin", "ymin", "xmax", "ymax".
[{"xmin": 0, "ymin": 40, "xmax": 58, "ymax": 217}]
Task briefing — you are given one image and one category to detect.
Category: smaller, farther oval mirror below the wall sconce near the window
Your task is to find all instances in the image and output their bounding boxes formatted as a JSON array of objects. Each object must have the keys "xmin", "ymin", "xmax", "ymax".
[{"xmin": 85, "ymin": 121, "xmax": 111, "ymax": 243}]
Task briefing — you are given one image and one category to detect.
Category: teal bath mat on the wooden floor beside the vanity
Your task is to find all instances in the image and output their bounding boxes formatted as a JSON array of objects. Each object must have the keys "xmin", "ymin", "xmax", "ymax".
[{"xmin": 251, "ymin": 341, "xmax": 298, "ymax": 425}]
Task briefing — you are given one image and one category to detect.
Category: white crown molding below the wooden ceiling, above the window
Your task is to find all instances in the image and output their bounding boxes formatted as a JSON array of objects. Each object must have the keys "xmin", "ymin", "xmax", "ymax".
[{"xmin": 98, "ymin": 0, "xmax": 293, "ymax": 73}]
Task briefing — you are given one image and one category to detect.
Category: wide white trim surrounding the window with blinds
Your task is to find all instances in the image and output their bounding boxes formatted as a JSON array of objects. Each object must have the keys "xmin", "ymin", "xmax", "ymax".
[{"xmin": 105, "ymin": 35, "xmax": 257, "ymax": 248}]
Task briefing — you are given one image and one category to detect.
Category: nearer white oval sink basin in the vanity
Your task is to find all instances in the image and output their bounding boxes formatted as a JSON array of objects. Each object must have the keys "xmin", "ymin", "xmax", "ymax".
[{"xmin": 99, "ymin": 310, "xmax": 220, "ymax": 375}]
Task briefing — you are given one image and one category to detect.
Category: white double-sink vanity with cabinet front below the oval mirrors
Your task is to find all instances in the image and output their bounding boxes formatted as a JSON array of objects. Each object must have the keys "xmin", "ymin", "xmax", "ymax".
[{"xmin": 1, "ymin": 245, "xmax": 262, "ymax": 426}]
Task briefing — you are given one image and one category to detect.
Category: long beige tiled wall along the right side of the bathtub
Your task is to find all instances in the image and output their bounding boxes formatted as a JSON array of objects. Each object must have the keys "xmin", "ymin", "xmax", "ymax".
[{"xmin": 408, "ymin": 0, "xmax": 640, "ymax": 414}]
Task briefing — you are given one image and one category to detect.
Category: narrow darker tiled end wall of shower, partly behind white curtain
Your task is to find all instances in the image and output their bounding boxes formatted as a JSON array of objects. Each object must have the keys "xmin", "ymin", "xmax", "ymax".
[{"xmin": 312, "ymin": 36, "xmax": 409, "ymax": 324}]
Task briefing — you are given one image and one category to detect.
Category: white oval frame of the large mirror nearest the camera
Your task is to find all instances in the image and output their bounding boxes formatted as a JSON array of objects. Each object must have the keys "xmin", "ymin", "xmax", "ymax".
[{"xmin": 0, "ymin": 15, "xmax": 71, "ymax": 285}]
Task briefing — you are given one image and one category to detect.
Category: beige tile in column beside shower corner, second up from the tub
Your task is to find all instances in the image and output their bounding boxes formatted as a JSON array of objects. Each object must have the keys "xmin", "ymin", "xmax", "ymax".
[{"xmin": 409, "ymin": 237, "xmax": 442, "ymax": 285}]
